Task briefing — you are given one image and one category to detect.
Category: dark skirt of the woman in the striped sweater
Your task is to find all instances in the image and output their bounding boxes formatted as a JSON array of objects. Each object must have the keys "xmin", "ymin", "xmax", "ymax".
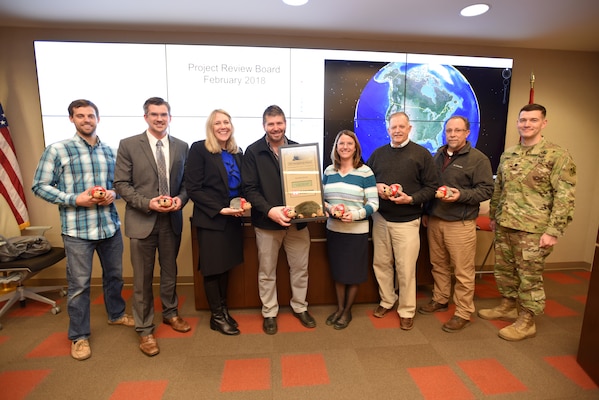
[{"xmin": 327, "ymin": 229, "xmax": 368, "ymax": 285}]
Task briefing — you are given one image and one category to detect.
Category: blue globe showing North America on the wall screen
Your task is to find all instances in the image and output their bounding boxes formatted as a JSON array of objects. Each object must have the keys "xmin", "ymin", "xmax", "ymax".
[{"xmin": 354, "ymin": 62, "xmax": 480, "ymax": 160}]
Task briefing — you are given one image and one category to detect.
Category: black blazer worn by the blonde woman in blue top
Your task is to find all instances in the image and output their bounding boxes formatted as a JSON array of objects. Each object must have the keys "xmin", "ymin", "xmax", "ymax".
[{"xmin": 185, "ymin": 140, "xmax": 242, "ymax": 231}]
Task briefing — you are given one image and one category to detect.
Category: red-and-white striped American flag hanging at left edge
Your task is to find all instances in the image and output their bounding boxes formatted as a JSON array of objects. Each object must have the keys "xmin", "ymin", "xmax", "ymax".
[{"xmin": 0, "ymin": 104, "xmax": 29, "ymax": 229}]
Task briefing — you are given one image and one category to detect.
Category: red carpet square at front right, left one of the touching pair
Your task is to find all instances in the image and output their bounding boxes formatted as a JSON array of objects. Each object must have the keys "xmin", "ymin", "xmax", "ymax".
[{"xmin": 408, "ymin": 365, "xmax": 474, "ymax": 400}]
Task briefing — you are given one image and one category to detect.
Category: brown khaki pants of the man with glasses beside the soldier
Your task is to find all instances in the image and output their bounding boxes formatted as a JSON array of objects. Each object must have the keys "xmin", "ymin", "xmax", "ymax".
[{"xmin": 427, "ymin": 217, "xmax": 476, "ymax": 320}]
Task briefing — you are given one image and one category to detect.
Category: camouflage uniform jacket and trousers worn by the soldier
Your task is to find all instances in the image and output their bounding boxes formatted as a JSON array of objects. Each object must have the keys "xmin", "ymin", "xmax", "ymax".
[{"xmin": 489, "ymin": 138, "xmax": 576, "ymax": 315}]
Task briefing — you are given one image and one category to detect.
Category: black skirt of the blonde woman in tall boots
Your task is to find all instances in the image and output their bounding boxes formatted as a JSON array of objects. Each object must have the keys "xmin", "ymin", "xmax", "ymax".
[{"xmin": 197, "ymin": 217, "xmax": 243, "ymax": 276}]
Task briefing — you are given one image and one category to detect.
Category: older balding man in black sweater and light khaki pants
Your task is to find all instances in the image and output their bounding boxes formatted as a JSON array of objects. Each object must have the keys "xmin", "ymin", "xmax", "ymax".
[{"xmin": 367, "ymin": 112, "xmax": 438, "ymax": 330}]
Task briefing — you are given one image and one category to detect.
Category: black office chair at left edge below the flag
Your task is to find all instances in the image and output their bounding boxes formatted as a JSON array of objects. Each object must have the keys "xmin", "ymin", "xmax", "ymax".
[{"xmin": 0, "ymin": 226, "xmax": 66, "ymax": 329}]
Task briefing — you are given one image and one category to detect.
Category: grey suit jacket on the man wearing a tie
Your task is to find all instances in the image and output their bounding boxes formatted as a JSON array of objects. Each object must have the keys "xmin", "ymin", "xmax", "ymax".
[{"xmin": 114, "ymin": 132, "xmax": 189, "ymax": 239}]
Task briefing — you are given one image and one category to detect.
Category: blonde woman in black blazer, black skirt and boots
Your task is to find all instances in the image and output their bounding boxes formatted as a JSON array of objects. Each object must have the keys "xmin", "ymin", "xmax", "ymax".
[{"xmin": 185, "ymin": 110, "xmax": 243, "ymax": 335}]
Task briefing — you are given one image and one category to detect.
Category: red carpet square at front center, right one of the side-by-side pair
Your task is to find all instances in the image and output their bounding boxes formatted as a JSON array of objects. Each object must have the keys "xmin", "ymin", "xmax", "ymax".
[{"xmin": 281, "ymin": 354, "xmax": 330, "ymax": 387}]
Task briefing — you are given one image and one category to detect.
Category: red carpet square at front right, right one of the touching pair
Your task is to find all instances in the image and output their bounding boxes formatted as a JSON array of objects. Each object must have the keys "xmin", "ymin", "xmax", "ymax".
[{"xmin": 458, "ymin": 358, "xmax": 528, "ymax": 395}]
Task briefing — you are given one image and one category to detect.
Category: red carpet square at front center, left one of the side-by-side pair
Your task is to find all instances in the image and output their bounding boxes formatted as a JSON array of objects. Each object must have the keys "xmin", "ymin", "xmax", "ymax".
[{"xmin": 220, "ymin": 358, "xmax": 271, "ymax": 392}]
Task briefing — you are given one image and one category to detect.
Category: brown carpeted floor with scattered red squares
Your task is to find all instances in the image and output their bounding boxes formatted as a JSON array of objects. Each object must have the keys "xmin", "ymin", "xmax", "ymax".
[{"xmin": 0, "ymin": 270, "xmax": 599, "ymax": 400}]
